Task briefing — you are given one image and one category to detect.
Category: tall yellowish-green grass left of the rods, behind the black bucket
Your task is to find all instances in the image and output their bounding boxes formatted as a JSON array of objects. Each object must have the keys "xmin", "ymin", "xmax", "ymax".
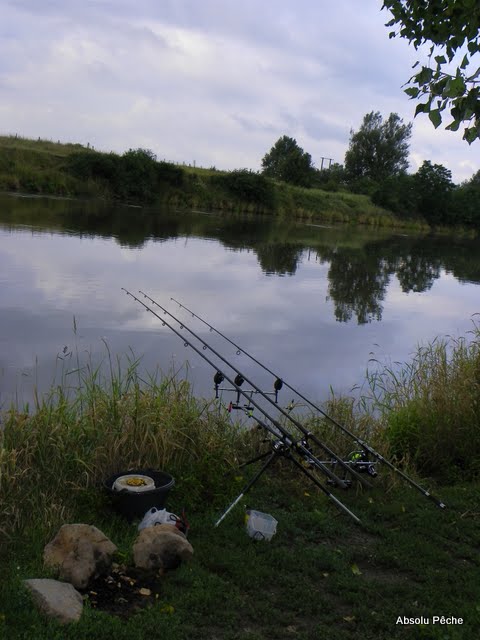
[{"xmin": 0, "ymin": 353, "xmax": 248, "ymax": 537}]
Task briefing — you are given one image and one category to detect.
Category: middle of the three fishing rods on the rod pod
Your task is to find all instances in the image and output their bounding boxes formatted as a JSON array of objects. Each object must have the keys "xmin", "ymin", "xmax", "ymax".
[{"xmin": 139, "ymin": 291, "xmax": 372, "ymax": 488}]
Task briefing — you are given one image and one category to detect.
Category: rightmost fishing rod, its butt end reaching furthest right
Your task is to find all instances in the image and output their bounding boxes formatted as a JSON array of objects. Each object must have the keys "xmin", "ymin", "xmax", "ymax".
[{"xmin": 170, "ymin": 298, "xmax": 446, "ymax": 509}]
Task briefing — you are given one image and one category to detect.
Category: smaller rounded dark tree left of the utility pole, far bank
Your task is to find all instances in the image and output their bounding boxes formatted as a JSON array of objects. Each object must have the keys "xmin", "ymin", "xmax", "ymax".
[{"xmin": 262, "ymin": 136, "xmax": 314, "ymax": 187}]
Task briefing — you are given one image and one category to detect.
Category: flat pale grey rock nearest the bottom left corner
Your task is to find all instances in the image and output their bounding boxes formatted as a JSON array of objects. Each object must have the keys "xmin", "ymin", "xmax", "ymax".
[{"xmin": 24, "ymin": 579, "xmax": 83, "ymax": 624}]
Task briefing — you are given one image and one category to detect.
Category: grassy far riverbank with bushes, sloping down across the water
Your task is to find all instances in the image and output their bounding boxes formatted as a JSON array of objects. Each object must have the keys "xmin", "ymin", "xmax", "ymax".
[{"xmin": 0, "ymin": 136, "xmax": 428, "ymax": 229}]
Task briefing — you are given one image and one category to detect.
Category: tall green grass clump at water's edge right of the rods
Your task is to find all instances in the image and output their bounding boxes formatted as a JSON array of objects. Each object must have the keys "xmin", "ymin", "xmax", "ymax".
[{"xmin": 363, "ymin": 324, "xmax": 480, "ymax": 481}]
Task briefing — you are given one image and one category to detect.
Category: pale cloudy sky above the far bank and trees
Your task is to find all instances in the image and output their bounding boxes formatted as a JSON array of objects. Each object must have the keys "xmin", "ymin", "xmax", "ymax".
[{"xmin": 0, "ymin": 0, "xmax": 480, "ymax": 182}]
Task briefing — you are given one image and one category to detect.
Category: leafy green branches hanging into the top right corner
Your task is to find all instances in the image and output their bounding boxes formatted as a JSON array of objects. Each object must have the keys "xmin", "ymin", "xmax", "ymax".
[{"xmin": 382, "ymin": 0, "xmax": 480, "ymax": 144}]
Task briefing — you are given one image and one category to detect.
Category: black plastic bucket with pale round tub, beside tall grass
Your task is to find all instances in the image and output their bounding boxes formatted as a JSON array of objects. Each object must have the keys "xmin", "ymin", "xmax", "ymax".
[{"xmin": 103, "ymin": 469, "xmax": 175, "ymax": 520}]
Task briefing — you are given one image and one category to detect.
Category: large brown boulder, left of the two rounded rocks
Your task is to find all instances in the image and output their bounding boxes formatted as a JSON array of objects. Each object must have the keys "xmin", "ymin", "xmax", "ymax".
[{"xmin": 43, "ymin": 524, "xmax": 117, "ymax": 589}]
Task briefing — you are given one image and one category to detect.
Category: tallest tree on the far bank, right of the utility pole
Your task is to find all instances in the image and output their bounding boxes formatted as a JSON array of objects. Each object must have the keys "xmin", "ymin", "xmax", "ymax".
[{"xmin": 345, "ymin": 111, "xmax": 412, "ymax": 182}]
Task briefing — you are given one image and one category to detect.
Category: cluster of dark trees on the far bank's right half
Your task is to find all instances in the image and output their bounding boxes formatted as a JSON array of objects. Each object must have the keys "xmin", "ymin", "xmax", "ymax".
[{"xmin": 262, "ymin": 111, "xmax": 480, "ymax": 227}]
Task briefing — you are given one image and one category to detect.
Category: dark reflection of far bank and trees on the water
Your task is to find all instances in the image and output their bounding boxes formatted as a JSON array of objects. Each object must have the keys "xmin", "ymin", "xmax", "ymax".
[{"xmin": 1, "ymin": 198, "xmax": 480, "ymax": 324}]
